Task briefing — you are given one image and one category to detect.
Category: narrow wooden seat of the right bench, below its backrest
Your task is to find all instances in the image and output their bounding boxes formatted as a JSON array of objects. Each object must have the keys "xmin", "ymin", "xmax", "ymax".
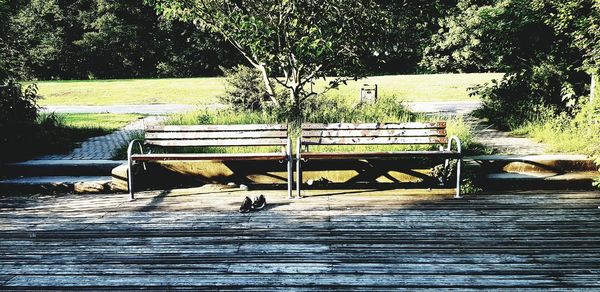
[{"xmin": 302, "ymin": 151, "xmax": 460, "ymax": 159}]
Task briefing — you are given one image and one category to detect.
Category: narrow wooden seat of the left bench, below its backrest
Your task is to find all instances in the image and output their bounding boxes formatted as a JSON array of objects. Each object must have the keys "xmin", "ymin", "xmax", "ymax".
[{"xmin": 131, "ymin": 153, "xmax": 287, "ymax": 161}]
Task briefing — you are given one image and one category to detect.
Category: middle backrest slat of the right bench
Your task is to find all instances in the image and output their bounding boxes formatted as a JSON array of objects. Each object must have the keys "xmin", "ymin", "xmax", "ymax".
[{"xmin": 302, "ymin": 129, "xmax": 446, "ymax": 138}]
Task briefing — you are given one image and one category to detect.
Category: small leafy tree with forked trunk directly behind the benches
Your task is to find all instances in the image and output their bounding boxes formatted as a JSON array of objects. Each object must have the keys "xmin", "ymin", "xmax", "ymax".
[{"xmin": 151, "ymin": 0, "xmax": 387, "ymax": 117}]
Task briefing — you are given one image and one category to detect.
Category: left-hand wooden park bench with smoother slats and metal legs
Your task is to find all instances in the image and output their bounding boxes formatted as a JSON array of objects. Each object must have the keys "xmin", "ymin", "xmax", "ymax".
[{"xmin": 127, "ymin": 124, "xmax": 293, "ymax": 199}]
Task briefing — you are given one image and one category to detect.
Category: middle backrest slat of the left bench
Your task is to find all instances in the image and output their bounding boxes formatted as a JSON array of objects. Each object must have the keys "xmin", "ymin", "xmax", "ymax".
[{"xmin": 146, "ymin": 131, "xmax": 287, "ymax": 140}]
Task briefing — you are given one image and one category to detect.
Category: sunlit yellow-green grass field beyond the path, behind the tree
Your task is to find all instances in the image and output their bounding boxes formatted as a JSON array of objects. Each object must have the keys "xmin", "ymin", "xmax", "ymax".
[{"xmin": 38, "ymin": 73, "xmax": 502, "ymax": 105}]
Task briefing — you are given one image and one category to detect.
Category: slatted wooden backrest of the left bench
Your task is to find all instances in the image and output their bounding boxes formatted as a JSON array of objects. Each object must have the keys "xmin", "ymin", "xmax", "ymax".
[{"xmin": 144, "ymin": 124, "xmax": 288, "ymax": 147}]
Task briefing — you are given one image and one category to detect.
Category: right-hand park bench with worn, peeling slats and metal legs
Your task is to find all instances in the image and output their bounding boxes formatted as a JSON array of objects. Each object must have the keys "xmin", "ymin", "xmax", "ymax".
[{"xmin": 296, "ymin": 122, "xmax": 463, "ymax": 199}]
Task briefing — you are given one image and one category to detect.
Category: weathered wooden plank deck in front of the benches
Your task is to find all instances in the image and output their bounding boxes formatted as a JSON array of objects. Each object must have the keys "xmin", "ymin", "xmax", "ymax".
[{"xmin": 0, "ymin": 188, "xmax": 600, "ymax": 291}]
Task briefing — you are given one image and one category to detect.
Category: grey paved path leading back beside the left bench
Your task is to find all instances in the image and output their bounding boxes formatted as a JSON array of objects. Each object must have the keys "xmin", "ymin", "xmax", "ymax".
[{"xmin": 36, "ymin": 116, "xmax": 165, "ymax": 160}]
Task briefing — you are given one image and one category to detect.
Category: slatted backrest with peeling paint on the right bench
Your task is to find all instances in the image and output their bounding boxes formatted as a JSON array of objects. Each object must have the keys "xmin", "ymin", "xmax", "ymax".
[{"xmin": 301, "ymin": 122, "xmax": 448, "ymax": 145}]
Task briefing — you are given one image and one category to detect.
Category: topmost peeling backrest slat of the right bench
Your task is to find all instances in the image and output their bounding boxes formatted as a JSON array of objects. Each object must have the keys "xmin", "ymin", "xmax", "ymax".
[{"xmin": 302, "ymin": 122, "xmax": 446, "ymax": 130}]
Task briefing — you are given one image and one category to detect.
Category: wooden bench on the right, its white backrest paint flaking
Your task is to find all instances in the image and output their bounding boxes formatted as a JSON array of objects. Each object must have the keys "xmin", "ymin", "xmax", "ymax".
[{"xmin": 296, "ymin": 122, "xmax": 462, "ymax": 198}]
